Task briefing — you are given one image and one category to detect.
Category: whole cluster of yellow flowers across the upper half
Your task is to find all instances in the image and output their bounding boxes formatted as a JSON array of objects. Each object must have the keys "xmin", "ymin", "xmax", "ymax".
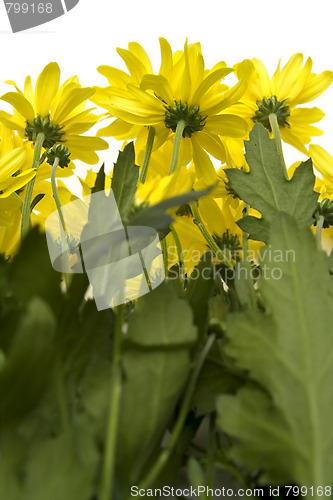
[{"xmin": 0, "ymin": 38, "xmax": 333, "ymax": 272}]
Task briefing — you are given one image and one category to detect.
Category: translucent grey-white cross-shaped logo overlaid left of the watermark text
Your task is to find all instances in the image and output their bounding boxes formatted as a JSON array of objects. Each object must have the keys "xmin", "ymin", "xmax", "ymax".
[{"xmin": 45, "ymin": 189, "xmax": 165, "ymax": 310}]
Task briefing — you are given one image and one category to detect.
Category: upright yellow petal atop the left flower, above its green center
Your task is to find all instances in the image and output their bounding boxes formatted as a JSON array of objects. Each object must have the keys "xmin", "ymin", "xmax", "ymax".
[{"xmin": 35, "ymin": 62, "xmax": 60, "ymax": 117}]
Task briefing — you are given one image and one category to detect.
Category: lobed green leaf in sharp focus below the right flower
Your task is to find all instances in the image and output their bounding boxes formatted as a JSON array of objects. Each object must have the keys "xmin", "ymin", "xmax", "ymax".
[{"xmin": 226, "ymin": 123, "xmax": 318, "ymax": 239}]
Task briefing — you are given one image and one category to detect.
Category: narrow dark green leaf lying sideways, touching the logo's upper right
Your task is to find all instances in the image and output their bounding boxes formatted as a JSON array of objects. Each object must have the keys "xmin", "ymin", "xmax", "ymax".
[{"xmin": 128, "ymin": 187, "xmax": 212, "ymax": 236}]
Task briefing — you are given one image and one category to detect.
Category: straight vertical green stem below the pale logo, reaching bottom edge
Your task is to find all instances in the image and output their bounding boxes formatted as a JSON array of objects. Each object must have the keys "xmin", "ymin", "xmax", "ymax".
[{"xmin": 100, "ymin": 304, "xmax": 124, "ymax": 500}]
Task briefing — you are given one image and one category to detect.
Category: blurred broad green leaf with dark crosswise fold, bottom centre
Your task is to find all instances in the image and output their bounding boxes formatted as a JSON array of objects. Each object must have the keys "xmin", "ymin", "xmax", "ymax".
[{"xmin": 118, "ymin": 284, "xmax": 197, "ymax": 484}]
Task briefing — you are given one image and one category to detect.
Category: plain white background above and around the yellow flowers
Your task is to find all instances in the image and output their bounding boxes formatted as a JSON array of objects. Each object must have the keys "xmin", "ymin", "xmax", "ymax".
[{"xmin": 0, "ymin": 0, "xmax": 333, "ymax": 168}]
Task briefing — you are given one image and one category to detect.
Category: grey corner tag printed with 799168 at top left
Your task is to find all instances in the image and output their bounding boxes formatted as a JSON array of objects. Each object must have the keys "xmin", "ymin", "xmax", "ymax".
[{"xmin": 3, "ymin": 0, "xmax": 79, "ymax": 33}]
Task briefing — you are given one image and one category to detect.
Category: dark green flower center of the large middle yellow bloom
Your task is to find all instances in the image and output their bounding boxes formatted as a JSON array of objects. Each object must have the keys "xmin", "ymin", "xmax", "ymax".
[{"xmin": 164, "ymin": 100, "xmax": 207, "ymax": 137}]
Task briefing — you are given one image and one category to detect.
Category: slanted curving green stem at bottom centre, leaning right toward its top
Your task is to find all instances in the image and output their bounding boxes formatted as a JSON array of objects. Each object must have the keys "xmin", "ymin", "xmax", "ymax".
[{"xmin": 137, "ymin": 334, "xmax": 215, "ymax": 490}]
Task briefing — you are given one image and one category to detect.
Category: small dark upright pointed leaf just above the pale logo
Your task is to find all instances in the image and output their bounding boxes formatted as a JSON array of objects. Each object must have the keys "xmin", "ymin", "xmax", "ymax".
[{"xmin": 111, "ymin": 142, "xmax": 139, "ymax": 221}]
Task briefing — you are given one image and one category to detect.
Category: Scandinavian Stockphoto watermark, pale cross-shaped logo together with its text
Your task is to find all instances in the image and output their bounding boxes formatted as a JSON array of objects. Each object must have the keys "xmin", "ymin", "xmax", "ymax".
[{"xmin": 45, "ymin": 189, "xmax": 296, "ymax": 310}]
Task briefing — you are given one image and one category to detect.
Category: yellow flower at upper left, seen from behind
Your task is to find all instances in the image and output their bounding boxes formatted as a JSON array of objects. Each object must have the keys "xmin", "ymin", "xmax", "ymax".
[{"xmin": 0, "ymin": 62, "xmax": 108, "ymax": 164}]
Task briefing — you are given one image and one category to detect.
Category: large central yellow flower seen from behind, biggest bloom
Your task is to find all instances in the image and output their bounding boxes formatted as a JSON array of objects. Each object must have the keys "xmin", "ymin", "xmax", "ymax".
[{"xmin": 92, "ymin": 38, "xmax": 248, "ymax": 184}]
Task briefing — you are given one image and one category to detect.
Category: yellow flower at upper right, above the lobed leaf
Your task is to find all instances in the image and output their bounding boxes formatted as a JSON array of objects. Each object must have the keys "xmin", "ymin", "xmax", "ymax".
[{"xmin": 233, "ymin": 54, "xmax": 333, "ymax": 154}]
